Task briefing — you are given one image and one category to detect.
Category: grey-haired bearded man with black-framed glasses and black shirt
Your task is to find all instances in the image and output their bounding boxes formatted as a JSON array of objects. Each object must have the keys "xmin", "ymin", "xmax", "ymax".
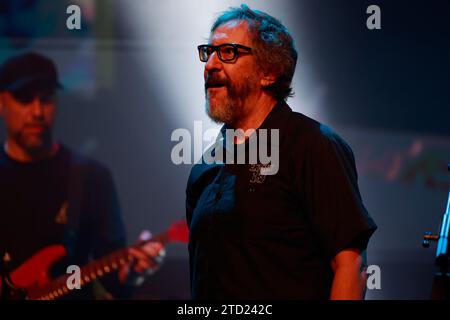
[{"xmin": 186, "ymin": 5, "xmax": 376, "ymax": 299}]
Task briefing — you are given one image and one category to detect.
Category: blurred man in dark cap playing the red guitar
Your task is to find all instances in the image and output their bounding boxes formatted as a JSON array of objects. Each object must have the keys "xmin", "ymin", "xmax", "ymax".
[{"xmin": 0, "ymin": 53, "xmax": 164, "ymax": 299}]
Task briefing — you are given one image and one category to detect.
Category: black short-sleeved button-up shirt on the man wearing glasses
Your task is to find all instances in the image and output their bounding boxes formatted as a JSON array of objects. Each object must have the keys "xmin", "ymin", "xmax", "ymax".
[{"xmin": 186, "ymin": 103, "xmax": 376, "ymax": 299}]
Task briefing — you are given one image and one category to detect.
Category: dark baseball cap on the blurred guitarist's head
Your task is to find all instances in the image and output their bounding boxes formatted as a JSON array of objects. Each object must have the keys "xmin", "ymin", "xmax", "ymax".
[{"xmin": 0, "ymin": 52, "xmax": 63, "ymax": 102}]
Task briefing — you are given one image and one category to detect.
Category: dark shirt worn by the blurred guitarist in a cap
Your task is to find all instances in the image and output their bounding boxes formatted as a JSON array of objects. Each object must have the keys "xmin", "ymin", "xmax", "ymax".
[{"xmin": 0, "ymin": 146, "xmax": 126, "ymax": 297}]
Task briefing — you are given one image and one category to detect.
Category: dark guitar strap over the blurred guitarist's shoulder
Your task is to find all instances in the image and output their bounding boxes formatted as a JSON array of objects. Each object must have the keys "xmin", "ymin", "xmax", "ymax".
[{"xmin": 65, "ymin": 152, "xmax": 87, "ymax": 257}]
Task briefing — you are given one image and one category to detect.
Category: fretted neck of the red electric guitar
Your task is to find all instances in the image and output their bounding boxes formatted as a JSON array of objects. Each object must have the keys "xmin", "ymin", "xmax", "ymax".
[{"xmin": 27, "ymin": 232, "xmax": 170, "ymax": 300}]
